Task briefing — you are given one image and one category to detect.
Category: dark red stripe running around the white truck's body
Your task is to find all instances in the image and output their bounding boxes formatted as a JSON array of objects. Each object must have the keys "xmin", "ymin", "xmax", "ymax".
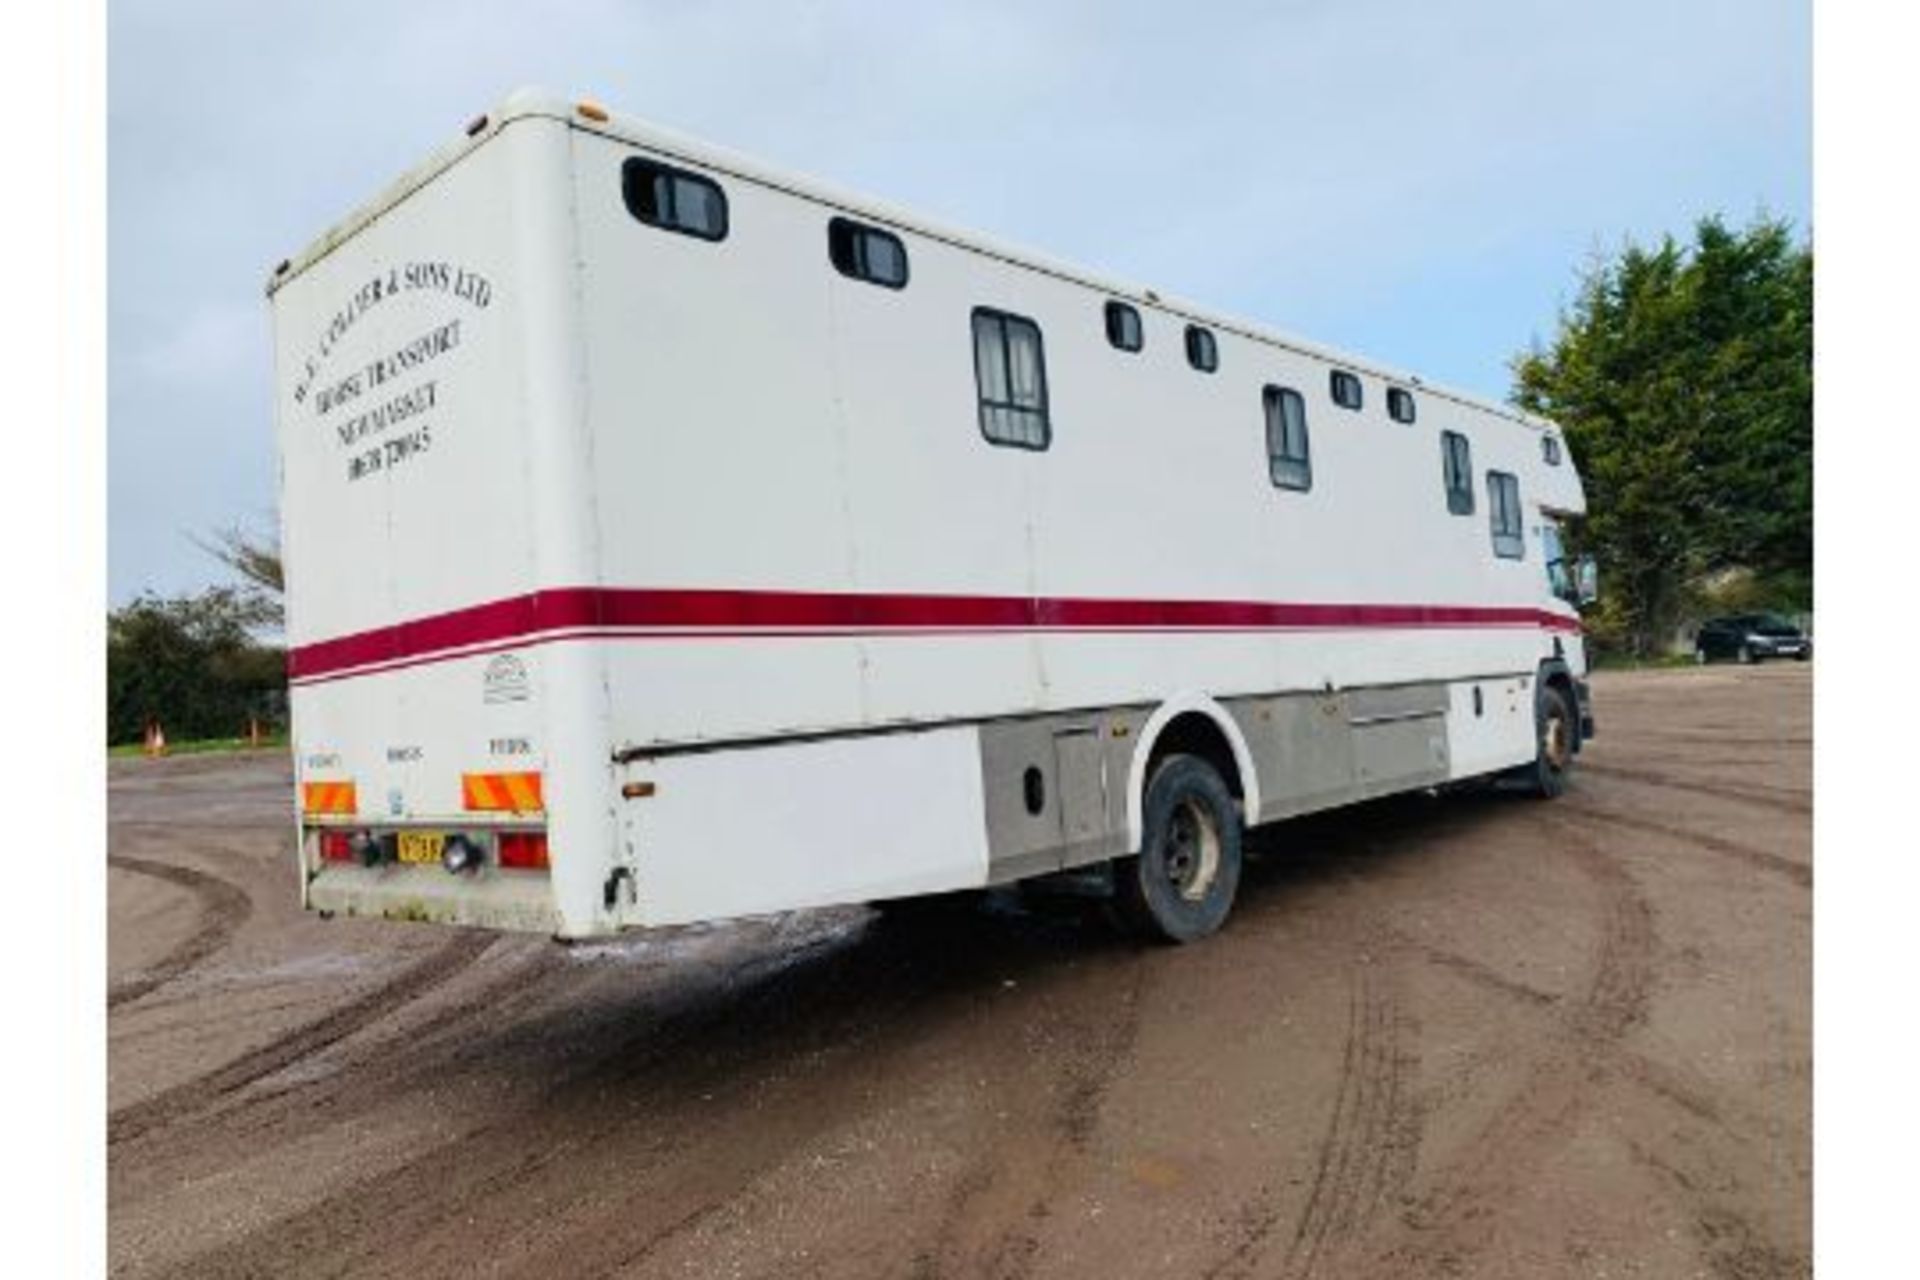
[{"xmin": 286, "ymin": 587, "xmax": 1580, "ymax": 681}]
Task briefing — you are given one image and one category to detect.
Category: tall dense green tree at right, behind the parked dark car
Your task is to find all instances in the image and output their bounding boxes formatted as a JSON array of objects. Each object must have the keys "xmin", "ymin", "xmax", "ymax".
[{"xmin": 1513, "ymin": 217, "xmax": 1812, "ymax": 654}]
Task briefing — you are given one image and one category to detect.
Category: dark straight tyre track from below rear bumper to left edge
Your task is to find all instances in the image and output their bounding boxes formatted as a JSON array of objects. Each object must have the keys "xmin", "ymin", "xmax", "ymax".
[{"xmin": 108, "ymin": 933, "xmax": 493, "ymax": 1146}]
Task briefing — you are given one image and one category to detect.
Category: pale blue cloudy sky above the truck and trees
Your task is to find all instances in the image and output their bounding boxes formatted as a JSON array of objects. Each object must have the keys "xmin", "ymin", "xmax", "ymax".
[{"xmin": 108, "ymin": 0, "xmax": 1812, "ymax": 603}]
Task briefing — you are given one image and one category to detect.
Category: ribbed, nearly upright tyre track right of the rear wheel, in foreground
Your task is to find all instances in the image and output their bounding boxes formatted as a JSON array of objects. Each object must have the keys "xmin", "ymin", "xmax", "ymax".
[{"xmin": 1206, "ymin": 942, "xmax": 1421, "ymax": 1280}]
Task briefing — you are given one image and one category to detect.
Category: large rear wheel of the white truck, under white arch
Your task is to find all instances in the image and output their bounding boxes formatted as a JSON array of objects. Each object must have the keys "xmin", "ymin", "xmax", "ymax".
[{"xmin": 1114, "ymin": 756, "xmax": 1240, "ymax": 942}]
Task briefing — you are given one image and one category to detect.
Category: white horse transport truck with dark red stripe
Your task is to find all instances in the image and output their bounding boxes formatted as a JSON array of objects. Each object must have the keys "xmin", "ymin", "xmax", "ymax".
[{"xmin": 269, "ymin": 92, "xmax": 1592, "ymax": 940}]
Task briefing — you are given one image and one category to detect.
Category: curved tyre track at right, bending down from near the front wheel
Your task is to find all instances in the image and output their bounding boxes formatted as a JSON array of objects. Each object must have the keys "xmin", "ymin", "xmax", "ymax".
[{"xmin": 1357, "ymin": 818, "xmax": 1655, "ymax": 1276}]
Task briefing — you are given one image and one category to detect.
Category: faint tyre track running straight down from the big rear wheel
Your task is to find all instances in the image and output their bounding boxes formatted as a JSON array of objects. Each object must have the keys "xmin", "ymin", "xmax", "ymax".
[{"xmin": 908, "ymin": 956, "xmax": 1150, "ymax": 1280}]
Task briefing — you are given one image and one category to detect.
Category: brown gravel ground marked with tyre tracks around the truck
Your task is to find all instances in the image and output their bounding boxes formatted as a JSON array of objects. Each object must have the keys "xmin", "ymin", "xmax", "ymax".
[{"xmin": 108, "ymin": 666, "xmax": 1812, "ymax": 1278}]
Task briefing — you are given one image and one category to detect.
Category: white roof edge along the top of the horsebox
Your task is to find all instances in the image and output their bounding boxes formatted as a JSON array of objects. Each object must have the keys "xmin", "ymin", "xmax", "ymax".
[{"xmin": 267, "ymin": 88, "xmax": 1557, "ymax": 432}]
